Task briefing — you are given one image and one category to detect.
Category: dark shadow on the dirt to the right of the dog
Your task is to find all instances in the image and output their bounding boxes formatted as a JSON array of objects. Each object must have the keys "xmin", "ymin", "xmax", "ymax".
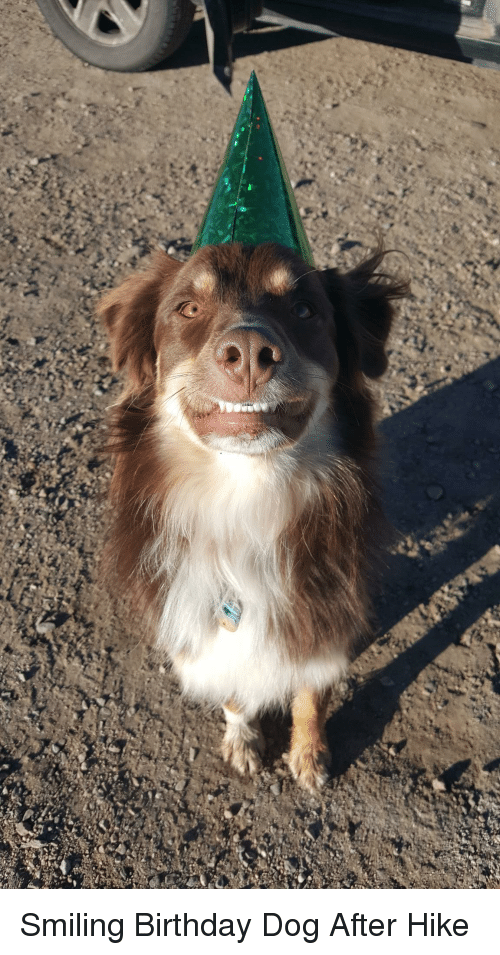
[{"xmin": 327, "ymin": 359, "xmax": 500, "ymax": 776}]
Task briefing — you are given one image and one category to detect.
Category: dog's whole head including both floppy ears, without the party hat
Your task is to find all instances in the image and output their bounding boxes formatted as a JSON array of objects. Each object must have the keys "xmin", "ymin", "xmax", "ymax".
[{"xmin": 100, "ymin": 243, "xmax": 404, "ymax": 454}]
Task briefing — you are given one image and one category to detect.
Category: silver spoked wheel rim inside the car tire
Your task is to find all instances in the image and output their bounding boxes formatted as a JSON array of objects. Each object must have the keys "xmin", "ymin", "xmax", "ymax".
[{"xmin": 59, "ymin": 0, "xmax": 149, "ymax": 46}]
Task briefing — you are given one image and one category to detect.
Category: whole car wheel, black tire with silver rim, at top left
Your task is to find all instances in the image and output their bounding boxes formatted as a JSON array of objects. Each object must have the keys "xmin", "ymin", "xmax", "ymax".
[{"xmin": 36, "ymin": 0, "xmax": 195, "ymax": 73}]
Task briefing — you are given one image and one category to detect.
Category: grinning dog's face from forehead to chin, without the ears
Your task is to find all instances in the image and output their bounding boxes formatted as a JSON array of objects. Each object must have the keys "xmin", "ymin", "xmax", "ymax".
[{"xmin": 155, "ymin": 245, "xmax": 337, "ymax": 454}]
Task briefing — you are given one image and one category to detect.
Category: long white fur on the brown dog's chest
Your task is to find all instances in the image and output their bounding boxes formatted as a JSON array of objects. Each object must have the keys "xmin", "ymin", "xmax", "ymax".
[{"xmin": 151, "ymin": 436, "xmax": 346, "ymax": 716}]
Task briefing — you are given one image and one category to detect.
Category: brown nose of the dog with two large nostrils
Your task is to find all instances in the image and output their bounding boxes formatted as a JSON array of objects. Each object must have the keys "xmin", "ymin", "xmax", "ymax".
[{"xmin": 215, "ymin": 328, "xmax": 283, "ymax": 394}]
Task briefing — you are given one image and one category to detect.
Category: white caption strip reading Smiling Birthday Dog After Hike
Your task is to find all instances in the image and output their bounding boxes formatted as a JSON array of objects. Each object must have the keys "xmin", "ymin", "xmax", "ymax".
[{"xmin": 0, "ymin": 889, "xmax": 488, "ymax": 955}]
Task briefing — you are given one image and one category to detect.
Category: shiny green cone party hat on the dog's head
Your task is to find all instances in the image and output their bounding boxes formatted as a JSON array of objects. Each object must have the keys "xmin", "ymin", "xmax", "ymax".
[{"xmin": 192, "ymin": 73, "xmax": 314, "ymax": 265}]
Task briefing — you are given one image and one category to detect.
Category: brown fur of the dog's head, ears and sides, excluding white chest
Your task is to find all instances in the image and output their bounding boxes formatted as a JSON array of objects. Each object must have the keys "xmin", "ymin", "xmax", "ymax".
[{"xmin": 99, "ymin": 245, "xmax": 407, "ymax": 788}]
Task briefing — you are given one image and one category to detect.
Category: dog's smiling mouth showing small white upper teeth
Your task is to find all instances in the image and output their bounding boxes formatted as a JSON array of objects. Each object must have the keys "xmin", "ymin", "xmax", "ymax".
[{"xmin": 186, "ymin": 395, "xmax": 313, "ymax": 440}]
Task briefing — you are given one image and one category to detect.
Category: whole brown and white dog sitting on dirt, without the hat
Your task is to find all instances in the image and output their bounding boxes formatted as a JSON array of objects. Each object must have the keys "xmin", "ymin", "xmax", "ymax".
[{"xmin": 99, "ymin": 243, "xmax": 406, "ymax": 790}]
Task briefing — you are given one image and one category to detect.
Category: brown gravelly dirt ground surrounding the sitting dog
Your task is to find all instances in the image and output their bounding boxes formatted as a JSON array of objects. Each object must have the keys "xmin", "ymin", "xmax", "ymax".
[{"xmin": 0, "ymin": 0, "xmax": 500, "ymax": 888}]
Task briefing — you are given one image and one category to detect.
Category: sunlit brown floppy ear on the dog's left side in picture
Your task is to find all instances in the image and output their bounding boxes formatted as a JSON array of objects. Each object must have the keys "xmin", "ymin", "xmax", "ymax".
[{"xmin": 97, "ymin": 251, "xmax": 182, "ymax": 394}]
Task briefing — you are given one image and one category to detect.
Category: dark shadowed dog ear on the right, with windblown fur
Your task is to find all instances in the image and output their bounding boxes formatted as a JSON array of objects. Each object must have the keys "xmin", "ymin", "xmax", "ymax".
[{"xmin": 323, "ymin": 245, "xmax": 410, "ymax": 378}]
